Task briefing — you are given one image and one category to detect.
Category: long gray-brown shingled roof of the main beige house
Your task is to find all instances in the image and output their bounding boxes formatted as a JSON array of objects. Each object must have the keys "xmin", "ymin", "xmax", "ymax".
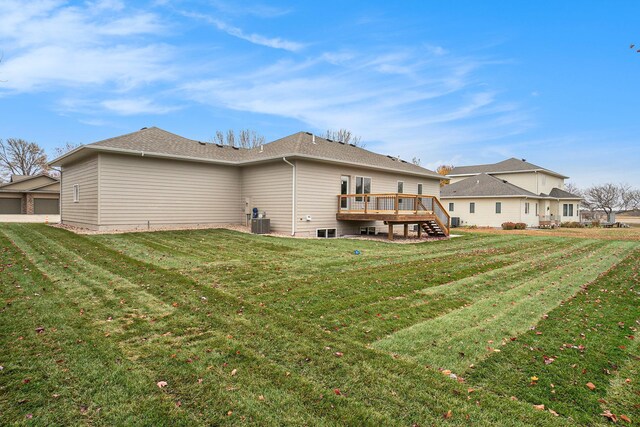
[{"xmin": 51, "ymin": 127, "xmax": 441, "ymax": 179}]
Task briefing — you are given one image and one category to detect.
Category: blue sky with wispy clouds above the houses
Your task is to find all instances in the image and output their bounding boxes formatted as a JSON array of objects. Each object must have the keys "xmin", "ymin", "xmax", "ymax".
[{"xmin": 0, "ymin": 0, "xmax": 640, "ymax": 187}]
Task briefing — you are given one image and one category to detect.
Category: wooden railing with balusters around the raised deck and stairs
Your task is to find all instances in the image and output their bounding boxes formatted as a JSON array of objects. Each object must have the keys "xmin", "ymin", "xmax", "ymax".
[{"xmin": 338, "ymin": 193, "xmax": 450, "ymax": 229}]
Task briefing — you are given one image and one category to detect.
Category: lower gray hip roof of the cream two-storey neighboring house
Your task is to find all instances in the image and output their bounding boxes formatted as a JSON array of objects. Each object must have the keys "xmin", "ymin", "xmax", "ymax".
[{"xmin": 440, "ymin": 173, "xmax": 540, "ymax": 199}]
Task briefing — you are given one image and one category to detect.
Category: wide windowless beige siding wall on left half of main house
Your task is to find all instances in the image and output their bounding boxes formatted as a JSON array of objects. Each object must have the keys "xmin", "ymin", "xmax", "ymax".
[{"xmin": 99, "ymin": 154, "xmax": 241, "ymax": 229}]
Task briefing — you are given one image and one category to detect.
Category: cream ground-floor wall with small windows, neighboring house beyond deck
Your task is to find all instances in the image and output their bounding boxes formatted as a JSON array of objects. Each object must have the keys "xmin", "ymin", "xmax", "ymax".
[{"xmin": 442, "ymin": 197, "xmax": 539, "ymax": 227}]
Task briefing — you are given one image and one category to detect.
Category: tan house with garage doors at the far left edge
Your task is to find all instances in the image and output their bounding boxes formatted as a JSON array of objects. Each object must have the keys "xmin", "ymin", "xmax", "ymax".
[{"xmin": 0, "ymin": 173, "xmax": 60, "ymax": 215}]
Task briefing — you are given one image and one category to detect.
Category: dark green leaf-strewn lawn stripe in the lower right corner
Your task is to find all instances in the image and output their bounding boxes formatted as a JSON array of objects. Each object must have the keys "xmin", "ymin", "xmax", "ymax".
[{"xmin": 467, "ymin": 249, "xmax": 640, "ymax": 425}]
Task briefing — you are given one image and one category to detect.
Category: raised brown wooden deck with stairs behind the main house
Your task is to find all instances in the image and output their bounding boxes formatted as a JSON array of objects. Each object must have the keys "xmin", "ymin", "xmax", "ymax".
[{"xmin": 336, "ymin": 193, "xmax": 450, "ymax": 240}]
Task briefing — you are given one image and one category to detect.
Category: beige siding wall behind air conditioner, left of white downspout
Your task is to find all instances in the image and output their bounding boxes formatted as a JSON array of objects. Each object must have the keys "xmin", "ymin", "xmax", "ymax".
[{"xmin": 241, "ymin": 160, "xmax": 293, "ymax": 234}]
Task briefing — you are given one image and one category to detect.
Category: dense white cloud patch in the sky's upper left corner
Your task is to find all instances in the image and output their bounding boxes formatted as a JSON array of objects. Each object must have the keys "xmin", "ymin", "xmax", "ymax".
[{"xmin": 0, "ymin": 1, "xmax": 175, "ymax": 94}]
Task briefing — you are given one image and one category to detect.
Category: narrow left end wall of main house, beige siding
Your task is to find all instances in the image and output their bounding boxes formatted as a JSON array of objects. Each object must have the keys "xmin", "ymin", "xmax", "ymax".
[{"xmin": 60, "ymin": 155, "xmax": 98, "ymax": 228}]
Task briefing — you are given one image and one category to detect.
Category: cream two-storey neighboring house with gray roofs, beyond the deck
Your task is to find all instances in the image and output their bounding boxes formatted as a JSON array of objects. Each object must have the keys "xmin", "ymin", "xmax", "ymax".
[{"xmin": 440, "ymin": 158, "xmax": 581, "ymax": 227}]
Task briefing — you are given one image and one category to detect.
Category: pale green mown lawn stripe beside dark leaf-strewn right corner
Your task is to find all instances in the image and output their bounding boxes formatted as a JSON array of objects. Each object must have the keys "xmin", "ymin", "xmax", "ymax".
[{"xmin": 374, "ymin": 242, "xmax": 635, "ymax": 373}]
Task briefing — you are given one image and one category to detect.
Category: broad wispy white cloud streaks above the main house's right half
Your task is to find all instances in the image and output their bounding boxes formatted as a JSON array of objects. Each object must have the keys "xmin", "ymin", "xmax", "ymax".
[{"xmin": 182, "ymin": 45, "xmax": 530, "ymax": 159}]
